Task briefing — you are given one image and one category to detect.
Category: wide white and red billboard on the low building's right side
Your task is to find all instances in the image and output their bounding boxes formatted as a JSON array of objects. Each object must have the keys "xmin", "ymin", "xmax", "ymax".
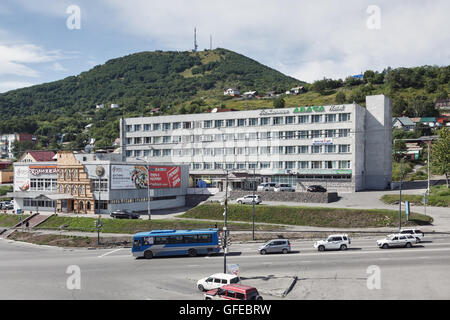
[{"xmin": 111, "ymin": 165, "xmax": 181, "ymax": 189}]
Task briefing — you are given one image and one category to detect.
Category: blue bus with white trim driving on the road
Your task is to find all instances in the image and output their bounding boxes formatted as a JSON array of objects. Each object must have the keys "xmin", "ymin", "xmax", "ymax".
[{"xmin": 131, "ymin": 228, "xmax": 220, "ymax": 259}]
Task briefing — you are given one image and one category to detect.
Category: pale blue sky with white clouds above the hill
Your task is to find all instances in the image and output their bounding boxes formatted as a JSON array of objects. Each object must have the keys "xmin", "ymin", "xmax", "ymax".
[{"xmin": 0, "ymin": 0, "xmax": 450, "ymax": 92}]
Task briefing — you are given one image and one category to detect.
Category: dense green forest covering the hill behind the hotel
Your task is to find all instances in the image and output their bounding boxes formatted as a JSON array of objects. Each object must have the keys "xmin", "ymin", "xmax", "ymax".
[{"xmin": 0, "ymin": 49, "xmax": 450, "ymax": 155}]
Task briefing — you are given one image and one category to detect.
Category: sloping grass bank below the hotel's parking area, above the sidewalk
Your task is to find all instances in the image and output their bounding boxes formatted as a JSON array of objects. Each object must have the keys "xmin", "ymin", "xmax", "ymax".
[{"xmin": 181, "ymin": 204, "xmax": 433, "ymax": 228}]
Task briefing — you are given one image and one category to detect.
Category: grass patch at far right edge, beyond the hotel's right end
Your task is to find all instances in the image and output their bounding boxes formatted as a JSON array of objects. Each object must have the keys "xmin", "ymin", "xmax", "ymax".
[{"xmin": 381, "ymin": 185, "xmax": 450, "ymax": 207}]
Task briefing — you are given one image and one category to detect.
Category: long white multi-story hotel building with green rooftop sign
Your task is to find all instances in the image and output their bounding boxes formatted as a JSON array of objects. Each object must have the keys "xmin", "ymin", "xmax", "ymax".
[{"xmin": 120, "ymin": 95, "xmax": 392, "ymax": 191}]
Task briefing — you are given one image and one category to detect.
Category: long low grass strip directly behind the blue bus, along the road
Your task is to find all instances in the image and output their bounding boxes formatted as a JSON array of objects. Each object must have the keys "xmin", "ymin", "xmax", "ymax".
[{"xmin": 34, "ymin": 216, "xmax": 282, "ymax": 234}]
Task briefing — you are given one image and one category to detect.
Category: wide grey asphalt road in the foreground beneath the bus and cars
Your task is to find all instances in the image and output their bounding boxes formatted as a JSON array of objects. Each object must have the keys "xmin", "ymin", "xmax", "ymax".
[{"xmin": 0, "ymin": 235, "xmax": 450, "ymax": 300}]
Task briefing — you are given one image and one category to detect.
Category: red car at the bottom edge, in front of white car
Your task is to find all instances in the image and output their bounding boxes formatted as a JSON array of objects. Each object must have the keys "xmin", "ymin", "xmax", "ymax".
[{"xmin": 205, "ymin": 284, "xmax": 263, "ymax": 300}]
